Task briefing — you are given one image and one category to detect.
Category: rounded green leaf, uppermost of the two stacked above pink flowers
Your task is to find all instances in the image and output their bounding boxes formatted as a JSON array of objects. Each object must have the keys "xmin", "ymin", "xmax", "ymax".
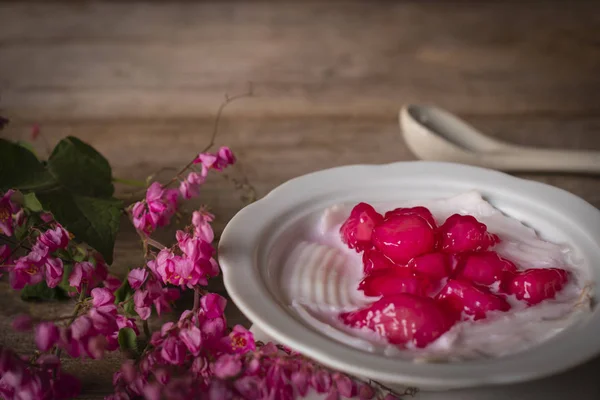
[{"xmin": 48, "ymin": 136, "xmax": 114, "ymax": 197}]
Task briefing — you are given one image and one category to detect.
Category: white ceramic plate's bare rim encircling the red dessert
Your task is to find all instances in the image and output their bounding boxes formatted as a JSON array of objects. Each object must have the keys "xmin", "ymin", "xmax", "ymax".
[{"xmin": 219, "ymin": 161, "xmax": 600, "ymax": 389}]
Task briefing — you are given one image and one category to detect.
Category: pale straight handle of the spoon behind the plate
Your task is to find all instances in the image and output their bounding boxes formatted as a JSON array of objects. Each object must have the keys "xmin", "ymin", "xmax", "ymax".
[{"xmin": 488, "ymin": 146, "xmax": 600, "ymax": 174}]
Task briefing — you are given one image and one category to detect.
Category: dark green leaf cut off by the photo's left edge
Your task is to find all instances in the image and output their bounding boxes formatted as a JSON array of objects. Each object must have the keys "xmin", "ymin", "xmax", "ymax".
[{"xmin": 0, "ymin": 139, "xmax": 57, "ymax": 191}]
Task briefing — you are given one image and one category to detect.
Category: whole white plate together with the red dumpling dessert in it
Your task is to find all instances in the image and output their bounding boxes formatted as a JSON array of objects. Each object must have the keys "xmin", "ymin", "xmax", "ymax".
[{"xmin": 219, "ymin": 161, "xmax": 600, "ymax": 390}]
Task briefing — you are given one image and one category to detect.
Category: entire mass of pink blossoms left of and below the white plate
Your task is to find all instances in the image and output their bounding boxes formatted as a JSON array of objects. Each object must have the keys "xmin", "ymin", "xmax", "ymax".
[{"xmin": 0, "ymin": 142, "xmax": 408, "ymax": 400}]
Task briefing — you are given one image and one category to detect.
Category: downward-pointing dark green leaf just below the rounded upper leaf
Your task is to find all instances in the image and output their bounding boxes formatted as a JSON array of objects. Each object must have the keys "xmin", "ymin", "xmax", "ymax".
[{"xmin": 37, "ymin": 188, "xmax": 122, "ymax": 264}]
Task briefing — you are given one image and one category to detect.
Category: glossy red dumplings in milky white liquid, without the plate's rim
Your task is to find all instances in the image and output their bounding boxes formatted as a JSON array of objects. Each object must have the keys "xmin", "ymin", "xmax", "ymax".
[{"xmin": 280, "ymin": 191, "xmax": 592, "ymax": 362}]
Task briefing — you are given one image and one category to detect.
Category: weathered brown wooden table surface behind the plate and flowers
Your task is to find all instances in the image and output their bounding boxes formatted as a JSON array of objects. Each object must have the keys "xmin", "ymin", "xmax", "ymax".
[{"xmin": 0, "ymin": 1, "xmax": 600, "ymax": 399}]
